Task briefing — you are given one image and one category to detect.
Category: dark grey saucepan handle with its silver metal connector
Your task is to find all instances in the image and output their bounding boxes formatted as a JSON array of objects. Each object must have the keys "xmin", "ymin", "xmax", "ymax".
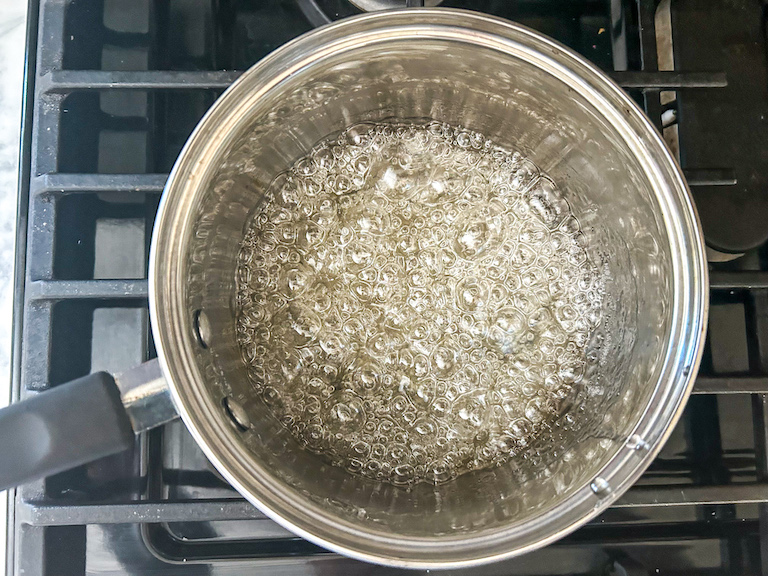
[{"xmin": 0, "ymin": 359, "xmax": 177, "ymax": 490}]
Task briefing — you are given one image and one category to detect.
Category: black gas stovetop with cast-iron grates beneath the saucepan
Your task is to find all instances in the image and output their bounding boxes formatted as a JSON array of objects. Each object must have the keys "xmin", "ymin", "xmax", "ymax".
[{"xmin": 8, "ymin": 0, "xmax": 768, "ymax": 576}]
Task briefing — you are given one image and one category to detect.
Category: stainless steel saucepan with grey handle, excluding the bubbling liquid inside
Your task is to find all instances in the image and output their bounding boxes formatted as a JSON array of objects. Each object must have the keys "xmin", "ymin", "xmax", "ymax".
[{"xmin": 0, "ymin": 8, "xmax": 708, "ymax": 568}]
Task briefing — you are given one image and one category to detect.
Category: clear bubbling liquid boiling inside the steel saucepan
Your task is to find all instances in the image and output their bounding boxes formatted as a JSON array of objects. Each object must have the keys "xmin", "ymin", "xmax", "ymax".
[{"xmin": 235, "ymin": 119, "xmax": 606, "ymax": 486}]
